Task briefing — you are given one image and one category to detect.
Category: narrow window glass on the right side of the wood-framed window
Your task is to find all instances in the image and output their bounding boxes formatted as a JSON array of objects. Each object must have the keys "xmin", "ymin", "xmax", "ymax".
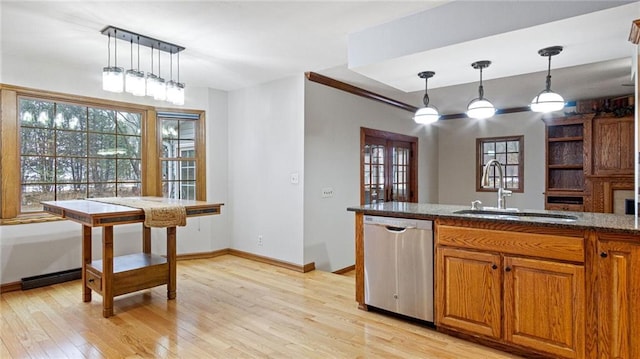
[{"xmin": 159, "ymin": 116, "xmax": 198, "ymax": 199}]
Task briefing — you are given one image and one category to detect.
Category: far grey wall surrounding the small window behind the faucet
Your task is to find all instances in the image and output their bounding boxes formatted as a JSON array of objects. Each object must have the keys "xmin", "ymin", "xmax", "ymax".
[{"xmin": 437, "ymin": 112, "xmax": 545, "ymax": 209}]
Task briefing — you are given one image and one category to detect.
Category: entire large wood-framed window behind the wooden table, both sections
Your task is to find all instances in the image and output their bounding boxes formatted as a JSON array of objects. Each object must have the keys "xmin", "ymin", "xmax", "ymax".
[{"xmin": 0, "ymin": 84, "xmax": 206, "ymax": 224}]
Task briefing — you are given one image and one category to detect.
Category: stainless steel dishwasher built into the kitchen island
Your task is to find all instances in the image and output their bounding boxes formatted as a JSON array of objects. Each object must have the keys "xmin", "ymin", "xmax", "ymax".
[{"xmin": 364, "ymin": 216, "xmax": 434, "ymax": 323}]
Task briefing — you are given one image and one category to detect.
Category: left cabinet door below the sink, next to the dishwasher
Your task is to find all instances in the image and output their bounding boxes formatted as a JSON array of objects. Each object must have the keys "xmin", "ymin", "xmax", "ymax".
[{"xmin": 436, "ymin": 247, "xmax": 502, "ymax": 338}]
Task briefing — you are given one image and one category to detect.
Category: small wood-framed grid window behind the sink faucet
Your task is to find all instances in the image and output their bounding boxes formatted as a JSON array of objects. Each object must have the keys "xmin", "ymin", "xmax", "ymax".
[{"xmin": 476, "ymin": 136, "xmax": 524, "ymax": 192}]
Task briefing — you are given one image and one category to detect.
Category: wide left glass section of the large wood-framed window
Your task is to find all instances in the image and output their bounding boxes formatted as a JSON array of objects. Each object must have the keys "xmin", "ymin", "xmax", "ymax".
[{"xmin": 18, "ymin": 98, "xmax": 142, "ymax": 212}]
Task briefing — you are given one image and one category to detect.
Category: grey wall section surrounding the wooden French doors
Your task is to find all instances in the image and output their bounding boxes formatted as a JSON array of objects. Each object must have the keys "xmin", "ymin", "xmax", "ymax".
[{"xmin": 304, "ymin": 81, "xmax": 438, "ymax": 271}]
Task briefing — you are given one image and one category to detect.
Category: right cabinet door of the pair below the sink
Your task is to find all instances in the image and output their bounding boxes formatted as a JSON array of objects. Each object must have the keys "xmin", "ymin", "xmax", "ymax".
[{"xmin": 504, "ymin": 256, "xmax": 585, "ymax": 358}]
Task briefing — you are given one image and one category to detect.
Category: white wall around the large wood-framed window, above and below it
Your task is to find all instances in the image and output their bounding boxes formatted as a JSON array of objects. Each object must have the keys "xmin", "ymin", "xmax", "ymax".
[{"xmin": 0, "ymin": 53, "xmax": 231, "ymax": 284}]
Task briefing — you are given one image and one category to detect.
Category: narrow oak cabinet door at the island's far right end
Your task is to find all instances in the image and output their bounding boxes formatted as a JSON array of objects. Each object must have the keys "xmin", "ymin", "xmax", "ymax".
[{"xmin": 598, "ymin": 241, "xmax": 640, "ymax": 359}]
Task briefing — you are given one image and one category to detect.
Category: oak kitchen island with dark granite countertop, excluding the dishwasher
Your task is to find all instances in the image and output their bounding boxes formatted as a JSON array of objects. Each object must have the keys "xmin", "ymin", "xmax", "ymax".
[{"xmin": 348, "ymin": 202, "xmax": 640, "ymax": 358}]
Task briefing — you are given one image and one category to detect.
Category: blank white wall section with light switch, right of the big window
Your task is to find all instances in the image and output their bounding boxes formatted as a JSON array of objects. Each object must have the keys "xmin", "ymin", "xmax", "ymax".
[{"xmin": 225, "ymin": 74, "xmax": 306, "ymax": 265}]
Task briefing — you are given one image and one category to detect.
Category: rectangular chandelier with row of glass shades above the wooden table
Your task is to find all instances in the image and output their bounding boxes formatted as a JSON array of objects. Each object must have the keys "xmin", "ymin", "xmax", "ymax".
[{"xmin": 101, "ymin": 26, "xmax": 185, "ymax": 105}]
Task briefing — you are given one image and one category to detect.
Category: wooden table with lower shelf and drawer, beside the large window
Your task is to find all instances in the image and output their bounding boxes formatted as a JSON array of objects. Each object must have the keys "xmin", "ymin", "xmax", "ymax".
[{"xmin": 42, "ymin": 197, "xmax": 222, "ymax": 318}]
